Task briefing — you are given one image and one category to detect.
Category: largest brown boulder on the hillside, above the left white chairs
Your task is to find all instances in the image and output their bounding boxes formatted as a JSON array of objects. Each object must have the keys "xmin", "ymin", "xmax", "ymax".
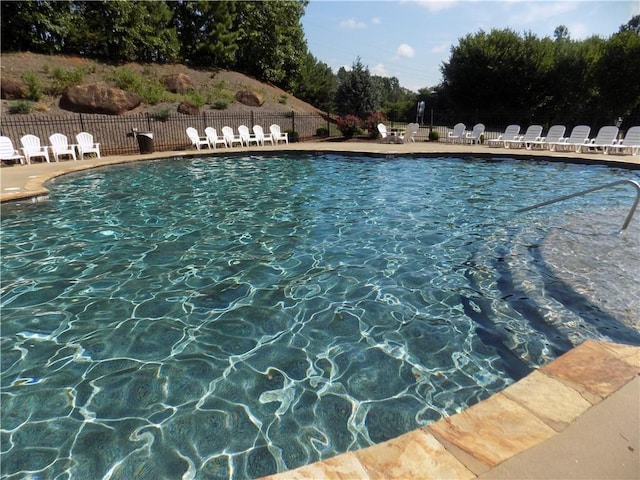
[{"xmin": 60, "ymin": 84, "xmax": 141, "ymax": 115}]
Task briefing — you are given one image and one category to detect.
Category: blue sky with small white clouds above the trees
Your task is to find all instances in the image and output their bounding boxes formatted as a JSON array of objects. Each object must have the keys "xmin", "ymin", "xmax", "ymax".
[{"xmin": 302, "ymin": 0, "xmax": 640, "ymax": 91}]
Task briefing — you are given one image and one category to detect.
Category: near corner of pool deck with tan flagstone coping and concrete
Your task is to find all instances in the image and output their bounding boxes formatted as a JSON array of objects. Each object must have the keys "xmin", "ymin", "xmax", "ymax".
[{"xmin": 264, "ymin": 340, "xmax": 640, "ymax": 480}]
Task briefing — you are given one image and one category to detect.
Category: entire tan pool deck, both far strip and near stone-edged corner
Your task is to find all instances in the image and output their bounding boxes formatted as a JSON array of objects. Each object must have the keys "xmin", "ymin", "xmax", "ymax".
[{"xmin": 0, "ymin": 142, "xmax": 640, "ymax": 480}]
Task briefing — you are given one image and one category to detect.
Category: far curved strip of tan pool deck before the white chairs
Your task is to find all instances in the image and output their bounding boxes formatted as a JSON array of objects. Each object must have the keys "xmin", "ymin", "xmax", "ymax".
[{"xmin": 0, "ymin": 142, "xmax": 640, "ymax": 203}]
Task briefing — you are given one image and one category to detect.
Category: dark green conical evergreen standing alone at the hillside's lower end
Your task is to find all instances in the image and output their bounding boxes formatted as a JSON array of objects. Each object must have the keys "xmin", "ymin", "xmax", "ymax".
[{"xmin": 335, "ymin": 57, "xmax": 376, "ymax": 118}]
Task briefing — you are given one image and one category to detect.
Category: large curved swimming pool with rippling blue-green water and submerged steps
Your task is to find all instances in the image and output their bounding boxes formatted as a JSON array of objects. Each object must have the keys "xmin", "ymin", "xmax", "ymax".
[{"xmin": 1, "ymin": 154, "xmax": 640, "ymax": 479}]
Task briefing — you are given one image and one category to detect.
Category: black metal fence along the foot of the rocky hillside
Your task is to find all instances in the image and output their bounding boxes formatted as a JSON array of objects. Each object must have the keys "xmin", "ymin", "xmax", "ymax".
[{"xmin": 0, "ymin": 111, "xmax": 336, "ymax": 155}]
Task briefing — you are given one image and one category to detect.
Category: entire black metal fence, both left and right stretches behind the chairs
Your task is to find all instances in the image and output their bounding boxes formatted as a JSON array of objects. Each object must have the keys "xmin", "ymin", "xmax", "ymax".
[{"xmin": 0, "ymin": 110, "xmax": 640, "ymax": 155}]
